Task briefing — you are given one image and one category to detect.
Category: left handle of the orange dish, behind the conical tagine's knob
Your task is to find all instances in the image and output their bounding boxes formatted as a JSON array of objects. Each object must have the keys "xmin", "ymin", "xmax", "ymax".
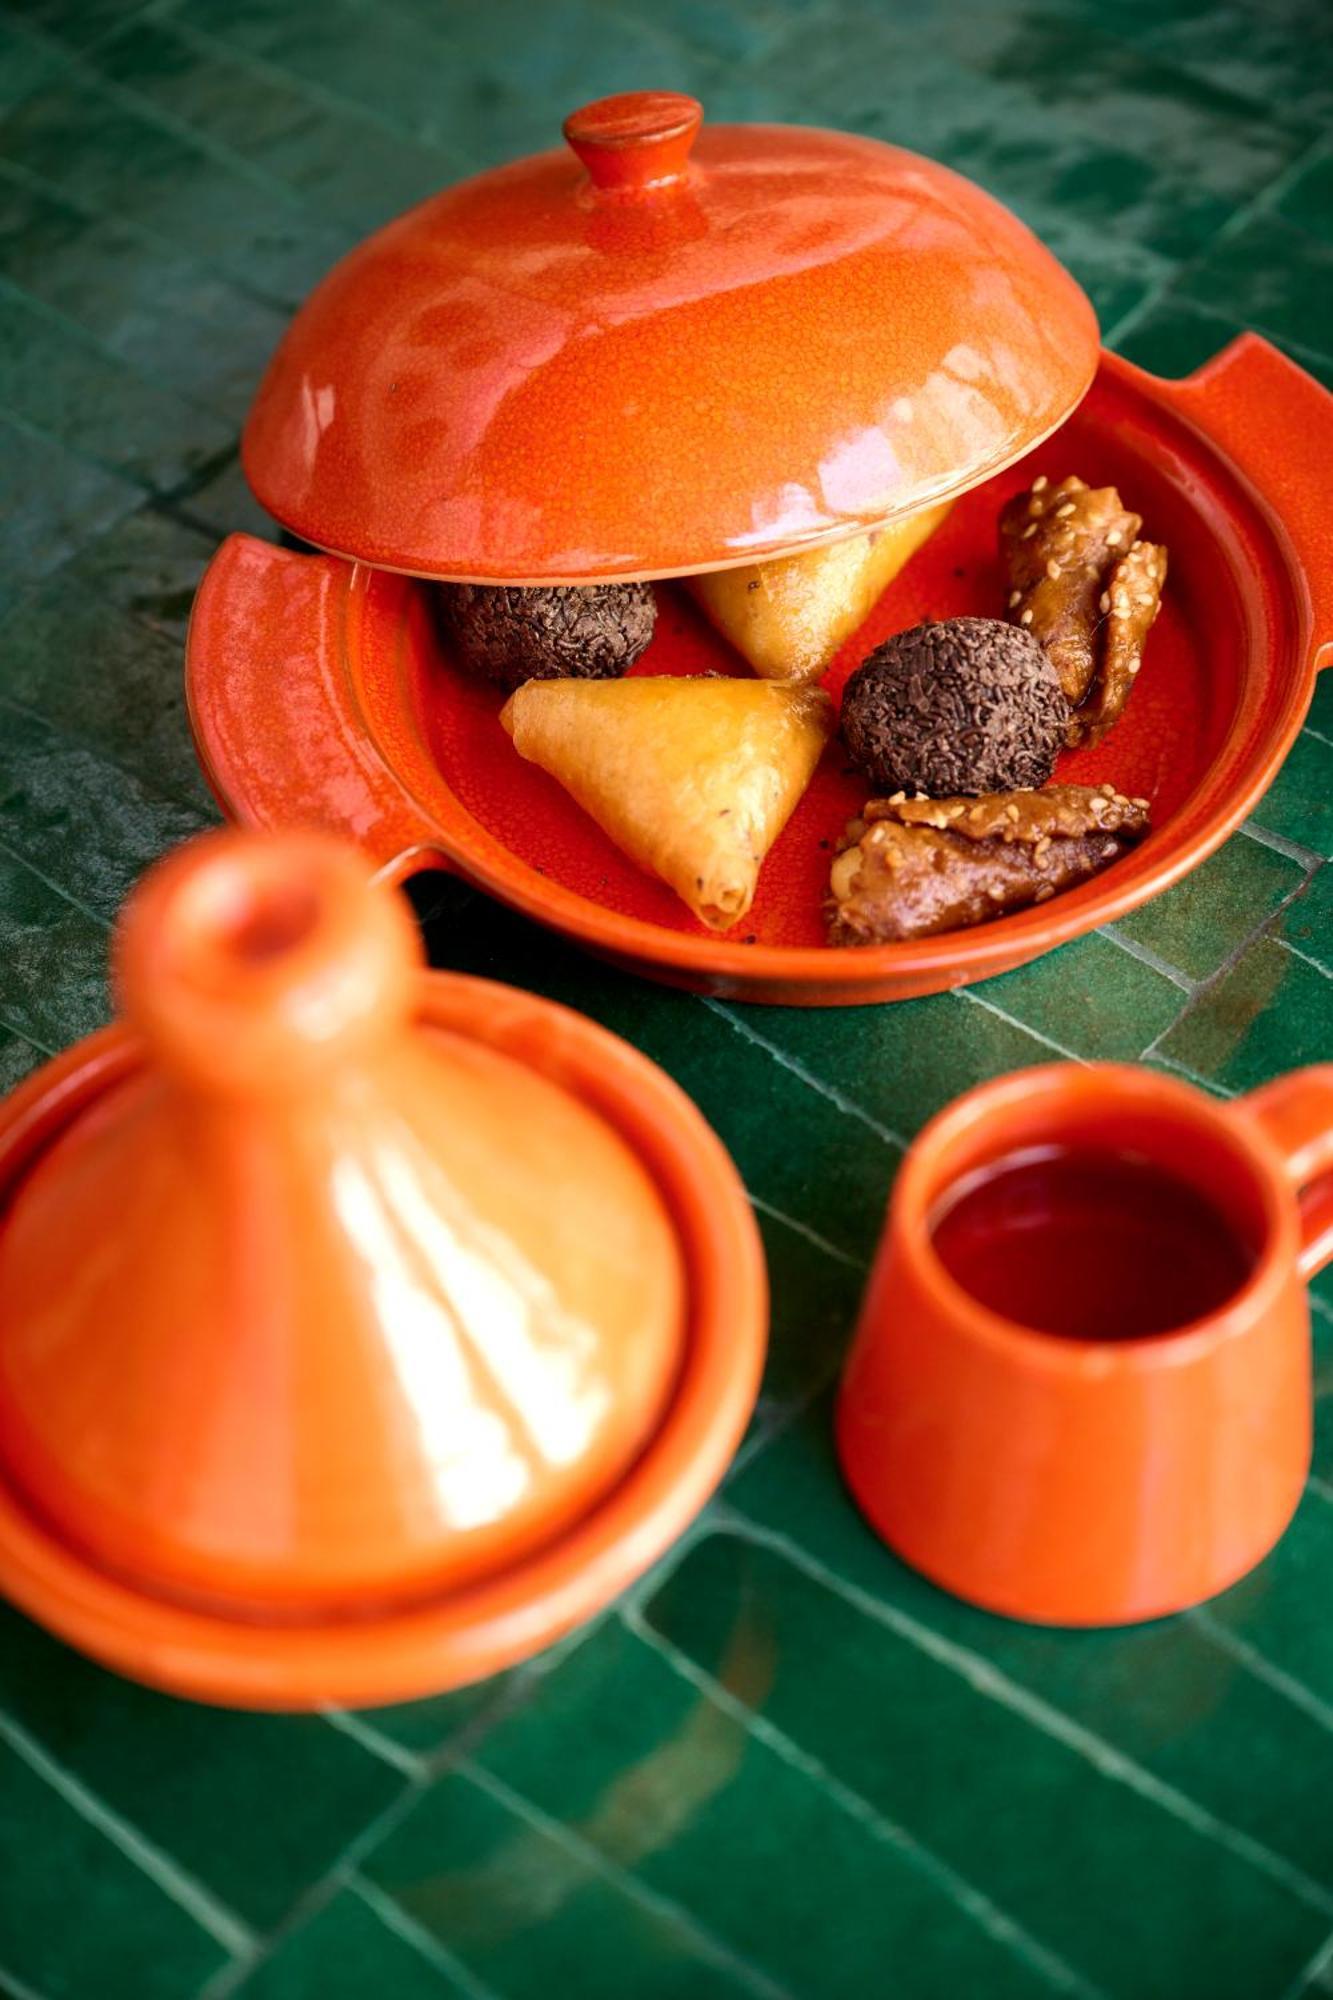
[{"xmin": 186, "ymin": 534, "xmax": 446, "ymax": 882}]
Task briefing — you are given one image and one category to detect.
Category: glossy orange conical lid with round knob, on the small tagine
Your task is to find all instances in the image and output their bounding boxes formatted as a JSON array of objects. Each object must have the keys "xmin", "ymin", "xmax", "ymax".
[{"xmin": 0, "ymin": 834, "xmax": 685, "ymax": 1618}]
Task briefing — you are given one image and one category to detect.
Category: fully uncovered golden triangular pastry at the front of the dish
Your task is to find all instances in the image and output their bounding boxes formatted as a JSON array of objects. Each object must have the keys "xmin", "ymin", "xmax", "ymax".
[{"xmin": 500, "ymin": 674, "xmax": 833, "ymax": 930}]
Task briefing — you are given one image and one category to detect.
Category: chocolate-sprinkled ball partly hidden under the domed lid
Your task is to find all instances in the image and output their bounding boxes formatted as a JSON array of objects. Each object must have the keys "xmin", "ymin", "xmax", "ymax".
[{"xmin": 440, "ymin": 584, "xmax": 656, "ymax": 694}]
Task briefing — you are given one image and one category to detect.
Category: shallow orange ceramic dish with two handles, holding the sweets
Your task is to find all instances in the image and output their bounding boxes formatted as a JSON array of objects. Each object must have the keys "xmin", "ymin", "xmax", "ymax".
[{"xmin": 186, "ymin": 336, "xmax": 1333, "ymax": 1006}]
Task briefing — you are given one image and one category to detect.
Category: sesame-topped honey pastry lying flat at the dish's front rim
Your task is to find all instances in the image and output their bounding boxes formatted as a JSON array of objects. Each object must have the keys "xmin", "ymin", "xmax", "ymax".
[{"xmin": 829, "ymin": 784, "xmax": 1149, "ymax": 944}]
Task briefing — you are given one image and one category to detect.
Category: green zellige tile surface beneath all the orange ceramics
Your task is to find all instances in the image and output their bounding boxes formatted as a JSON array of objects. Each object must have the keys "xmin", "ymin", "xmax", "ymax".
[{"xmin": 0, "ymin": 0, "xmax": 1333, "ymax": 2000}]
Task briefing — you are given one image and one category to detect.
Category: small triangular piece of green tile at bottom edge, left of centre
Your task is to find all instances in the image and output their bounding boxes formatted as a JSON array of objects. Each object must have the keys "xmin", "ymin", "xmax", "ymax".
[{"xmin": 236, "ymin": 1888, "xmax": 466, "ymax": 2000}]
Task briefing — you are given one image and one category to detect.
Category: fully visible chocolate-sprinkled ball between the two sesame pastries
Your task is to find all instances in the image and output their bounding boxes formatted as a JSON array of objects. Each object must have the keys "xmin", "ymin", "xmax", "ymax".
[{"xmin": 843, "ymin": 618, "xmax": 1069, "ymax": 798}]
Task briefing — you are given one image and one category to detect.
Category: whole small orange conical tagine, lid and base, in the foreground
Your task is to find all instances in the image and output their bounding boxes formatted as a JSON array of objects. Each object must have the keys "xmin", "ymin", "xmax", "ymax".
[{"xmin": 0, "ymin": 832, "xmax": 765, "ymax": 1706}]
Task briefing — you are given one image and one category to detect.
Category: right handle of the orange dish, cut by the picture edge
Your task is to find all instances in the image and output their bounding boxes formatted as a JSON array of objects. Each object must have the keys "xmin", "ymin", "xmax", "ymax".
[{"xmin": 1157, "ymin": 334, "xmax": 1333, "ymax": 668}]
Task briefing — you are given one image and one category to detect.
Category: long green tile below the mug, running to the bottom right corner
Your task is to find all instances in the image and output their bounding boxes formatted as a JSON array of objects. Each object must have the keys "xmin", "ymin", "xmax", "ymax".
[{"xmin": 646, "ymin": 1534, "xmax": 1329, "ymax": 2000}]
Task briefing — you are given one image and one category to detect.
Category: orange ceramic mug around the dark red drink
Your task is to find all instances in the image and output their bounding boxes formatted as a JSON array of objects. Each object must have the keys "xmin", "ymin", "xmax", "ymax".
[{"xmin": 837, "ymin": 1064, "xmax": 1333, "ymax": 1626}]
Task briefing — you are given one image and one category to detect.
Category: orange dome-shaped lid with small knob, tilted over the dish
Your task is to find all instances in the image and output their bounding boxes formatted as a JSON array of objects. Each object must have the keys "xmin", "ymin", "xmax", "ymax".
[{"xmin": 244, "ymin": 92, "xmax": 1097, "ymax": 584}]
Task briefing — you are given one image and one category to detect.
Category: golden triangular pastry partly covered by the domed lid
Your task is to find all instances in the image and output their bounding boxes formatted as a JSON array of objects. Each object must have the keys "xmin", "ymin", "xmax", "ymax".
[{"xmin": 691, "ymin": 504, "xmax": 949, "ymax": 680}]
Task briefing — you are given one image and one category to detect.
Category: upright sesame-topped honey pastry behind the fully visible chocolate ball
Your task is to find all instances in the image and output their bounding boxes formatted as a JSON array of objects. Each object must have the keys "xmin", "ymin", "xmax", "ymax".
[{"xmin": 999, "ymin": 476, "xmax": 1167, "ymax": 750}]
